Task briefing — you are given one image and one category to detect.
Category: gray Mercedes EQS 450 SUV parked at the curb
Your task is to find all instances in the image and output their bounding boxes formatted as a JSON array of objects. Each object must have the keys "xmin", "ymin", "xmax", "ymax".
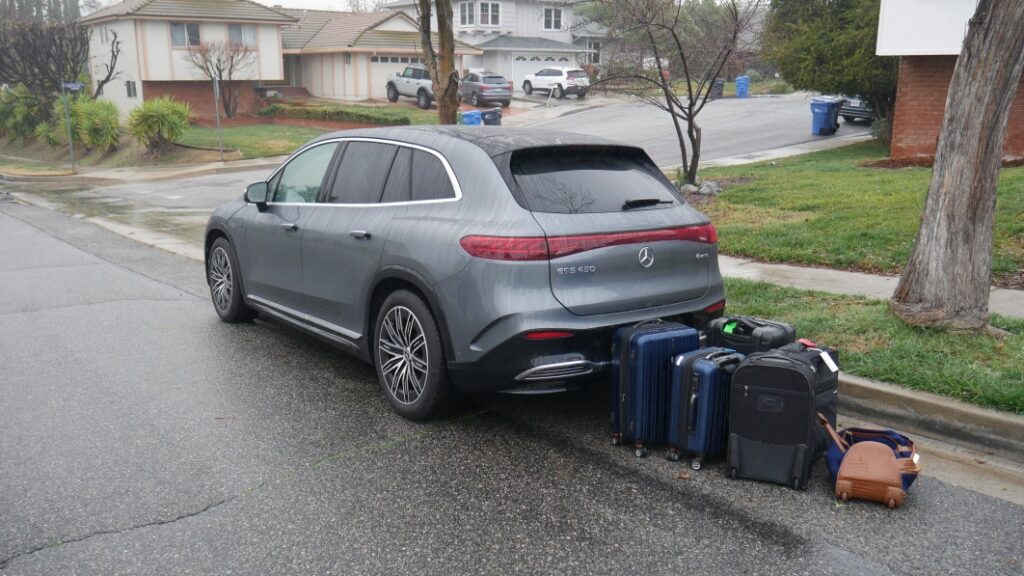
[{"xmin": 206, "ymin": 126, "xmax": 725, "ymax": 419}]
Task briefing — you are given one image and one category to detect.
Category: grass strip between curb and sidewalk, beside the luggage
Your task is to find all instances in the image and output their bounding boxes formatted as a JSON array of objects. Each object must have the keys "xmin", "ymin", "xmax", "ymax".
[{"xmin": 725, "ymin": 279, "xmax": 1024, "ymax": 414}]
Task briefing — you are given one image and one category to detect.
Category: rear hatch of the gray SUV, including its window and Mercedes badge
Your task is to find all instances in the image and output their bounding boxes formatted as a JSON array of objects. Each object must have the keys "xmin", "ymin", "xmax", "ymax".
[{"xmin": 509, "ymin": 147, "xmax": 717, "ymax": 316}]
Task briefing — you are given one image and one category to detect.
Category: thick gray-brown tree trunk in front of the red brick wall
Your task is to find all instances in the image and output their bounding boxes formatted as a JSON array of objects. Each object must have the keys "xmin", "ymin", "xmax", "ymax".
[{"xmin": 892, "ymin": 0, "xmax": 1024, "ymax": 330}]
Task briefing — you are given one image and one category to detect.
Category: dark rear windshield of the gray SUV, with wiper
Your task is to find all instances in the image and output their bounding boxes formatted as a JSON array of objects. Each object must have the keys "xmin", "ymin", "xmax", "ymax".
[{"xmin": 509, "ymin": 147, "xmax": 682, "ymax": 214}]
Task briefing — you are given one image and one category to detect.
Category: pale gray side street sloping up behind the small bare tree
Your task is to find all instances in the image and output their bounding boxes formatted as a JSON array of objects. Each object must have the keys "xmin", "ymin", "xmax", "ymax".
[{"xmin": 531, "ymin": 94, "xmax": 870, "ymax": 167}]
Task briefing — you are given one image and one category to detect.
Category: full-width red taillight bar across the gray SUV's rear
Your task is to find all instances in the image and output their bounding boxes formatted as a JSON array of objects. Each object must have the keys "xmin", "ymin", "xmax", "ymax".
[{"xmin": 459, "ymin": 224, "xmax": 718, "ymax": 260}]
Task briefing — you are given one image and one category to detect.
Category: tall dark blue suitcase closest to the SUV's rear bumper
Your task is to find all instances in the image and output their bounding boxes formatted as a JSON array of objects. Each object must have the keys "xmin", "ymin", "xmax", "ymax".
[{"xmin": 611, "ymin": 322, "xmax": 700, "ymax": 458}]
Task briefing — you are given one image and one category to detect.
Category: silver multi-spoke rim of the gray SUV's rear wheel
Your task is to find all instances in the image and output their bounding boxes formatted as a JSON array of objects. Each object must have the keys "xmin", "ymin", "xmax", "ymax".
[{"xmin": 377, "ymin": 306, "xmax": 429, "ymax": 404}]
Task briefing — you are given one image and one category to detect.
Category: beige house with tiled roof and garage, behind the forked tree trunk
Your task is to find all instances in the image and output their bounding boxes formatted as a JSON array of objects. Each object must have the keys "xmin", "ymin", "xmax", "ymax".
[{"xmin": 279, "ymin": 8, "xmax": 482, "ymax": 100}]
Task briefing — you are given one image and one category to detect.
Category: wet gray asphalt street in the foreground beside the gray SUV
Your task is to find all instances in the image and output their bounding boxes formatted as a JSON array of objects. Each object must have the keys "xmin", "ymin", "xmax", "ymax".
[{"xmin": 0, "ymin": 196, "xmax": 1024, "ymax": 575}]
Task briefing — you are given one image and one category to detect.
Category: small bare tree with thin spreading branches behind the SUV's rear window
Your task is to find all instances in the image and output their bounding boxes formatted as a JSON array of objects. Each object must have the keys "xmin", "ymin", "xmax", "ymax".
[{"xmin": 590, "ymin": 0, "xmax": 761, "ymax": 183}]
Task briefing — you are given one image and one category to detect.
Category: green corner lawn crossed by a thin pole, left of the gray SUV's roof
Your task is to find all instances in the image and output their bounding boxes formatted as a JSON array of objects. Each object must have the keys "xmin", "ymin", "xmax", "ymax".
[{"xmin": 181, "ymin": 124, "xmax": 330, "ymax": 158}]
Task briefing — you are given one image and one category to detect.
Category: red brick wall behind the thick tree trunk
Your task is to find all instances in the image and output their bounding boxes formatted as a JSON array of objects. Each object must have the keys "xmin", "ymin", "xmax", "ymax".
[{"xmin": 892, "ymin": 56, "xmax": 1024, "ymax": 158}]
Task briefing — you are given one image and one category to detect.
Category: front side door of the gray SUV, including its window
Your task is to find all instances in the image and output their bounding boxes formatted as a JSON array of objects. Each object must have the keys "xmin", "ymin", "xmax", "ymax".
[{"xmin": 243, "ymin": 141, "xmax": 339, "ymax": 315}]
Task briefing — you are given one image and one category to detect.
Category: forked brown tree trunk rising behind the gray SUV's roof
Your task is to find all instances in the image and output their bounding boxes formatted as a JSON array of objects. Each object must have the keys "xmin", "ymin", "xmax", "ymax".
[{"xmin": 417, "ymin": 0, "xmax": 459, "ymax": 124}]
